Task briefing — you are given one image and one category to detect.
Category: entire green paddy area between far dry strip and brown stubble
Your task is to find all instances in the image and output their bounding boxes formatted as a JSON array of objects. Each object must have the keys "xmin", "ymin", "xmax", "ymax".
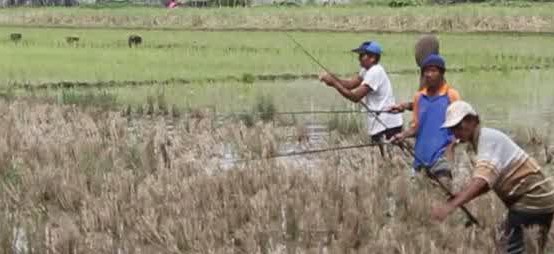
[{"xmin": 0, "ymin": 25, "xmax": 554, "ymax": 131}]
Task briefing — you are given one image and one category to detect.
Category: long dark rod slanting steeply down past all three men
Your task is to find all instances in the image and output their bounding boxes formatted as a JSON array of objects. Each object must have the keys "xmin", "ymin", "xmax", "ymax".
[{"xmin": 285, "ymin": 32, "xmax": 480, "ymax": 226}]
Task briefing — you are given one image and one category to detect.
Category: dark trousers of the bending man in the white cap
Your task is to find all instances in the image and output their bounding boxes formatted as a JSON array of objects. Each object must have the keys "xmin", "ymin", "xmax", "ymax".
[{"xmin": 497, "ymin": 210, "xmax": 553, "ymax": 254}]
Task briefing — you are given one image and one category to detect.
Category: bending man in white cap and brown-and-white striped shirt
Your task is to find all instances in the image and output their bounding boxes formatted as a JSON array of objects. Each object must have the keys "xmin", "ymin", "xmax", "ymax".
[{"xmin": 432, "ymin": 101, "xmax": 554, "ymax": 254}]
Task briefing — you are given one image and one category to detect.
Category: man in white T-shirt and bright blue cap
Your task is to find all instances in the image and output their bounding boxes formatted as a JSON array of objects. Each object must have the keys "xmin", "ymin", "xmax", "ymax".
[{"xmin": 320, "ymin": 41, "xmax": 403, "ymax": 155}]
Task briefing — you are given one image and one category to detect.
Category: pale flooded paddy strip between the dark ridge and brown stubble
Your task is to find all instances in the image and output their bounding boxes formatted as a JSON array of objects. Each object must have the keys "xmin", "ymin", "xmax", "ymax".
[{"xmin": 35, "ymin": 67, "xmax": 554, "ymax": 136}]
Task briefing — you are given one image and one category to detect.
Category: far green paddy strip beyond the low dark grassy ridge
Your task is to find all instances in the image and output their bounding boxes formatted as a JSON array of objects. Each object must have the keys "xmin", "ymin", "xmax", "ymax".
[{"xmin": 0, "ymin": 27, "xmax": 554, "ymax": 85}]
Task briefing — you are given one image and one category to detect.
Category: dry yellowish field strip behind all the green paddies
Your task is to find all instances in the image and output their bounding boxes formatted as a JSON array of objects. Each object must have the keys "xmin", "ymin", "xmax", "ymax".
[{"xmin": 0, "ymin": 2, "xmax": 554, "ymax": 32}]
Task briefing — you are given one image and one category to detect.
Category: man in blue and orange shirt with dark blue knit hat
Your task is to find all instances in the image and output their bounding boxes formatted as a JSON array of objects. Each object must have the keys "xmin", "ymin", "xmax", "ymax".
[{"xmin": 392, "ymin": 54, "xmax": 460, "ymax": 189}]
